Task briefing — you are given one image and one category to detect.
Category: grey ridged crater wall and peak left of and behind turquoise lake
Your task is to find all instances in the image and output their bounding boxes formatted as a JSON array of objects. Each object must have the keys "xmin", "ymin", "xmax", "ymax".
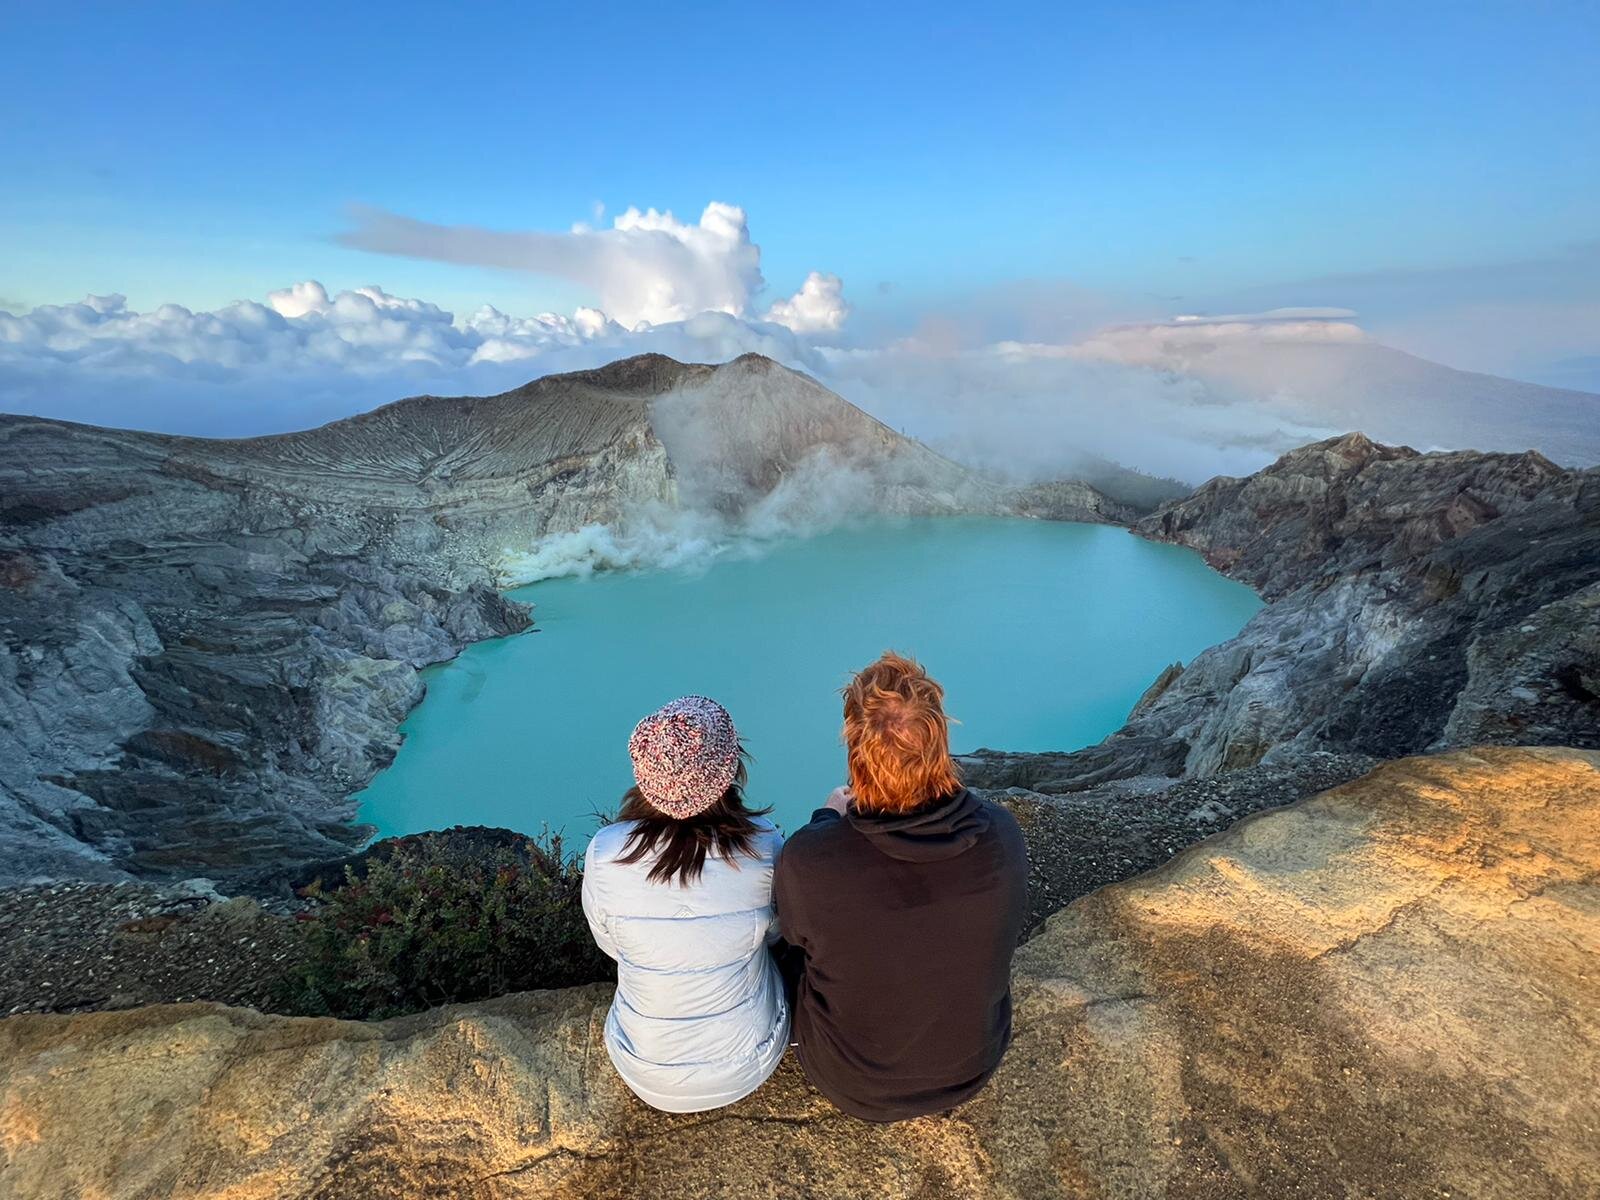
[{"xmin": 0, "ymin": 355, "xmax": 1131, "ymax": 886}]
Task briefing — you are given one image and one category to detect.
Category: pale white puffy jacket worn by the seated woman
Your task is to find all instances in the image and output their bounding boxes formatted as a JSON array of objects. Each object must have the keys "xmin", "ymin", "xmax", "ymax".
[{"xmin": 584, "ymin": 818, "xmax": 789, "ymax": 1112}]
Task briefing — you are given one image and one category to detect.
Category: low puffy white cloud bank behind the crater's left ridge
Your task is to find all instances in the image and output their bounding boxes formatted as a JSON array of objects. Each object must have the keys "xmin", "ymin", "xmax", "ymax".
[{"xmin": 0, "ymin": 280, "xmax": 819, "ymax": 435}]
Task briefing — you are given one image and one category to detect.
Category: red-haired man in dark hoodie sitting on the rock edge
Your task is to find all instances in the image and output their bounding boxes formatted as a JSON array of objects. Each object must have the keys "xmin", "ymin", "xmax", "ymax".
[{"xmin": 774, "ymin": 653, "xmax": 1027, "ymax": 1122}]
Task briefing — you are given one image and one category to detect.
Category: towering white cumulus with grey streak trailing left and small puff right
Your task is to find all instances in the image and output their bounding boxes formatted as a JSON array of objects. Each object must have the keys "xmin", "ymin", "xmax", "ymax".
[{"xmin": 339, "ymin": 202, "xmax": 848, "ymax": 333}]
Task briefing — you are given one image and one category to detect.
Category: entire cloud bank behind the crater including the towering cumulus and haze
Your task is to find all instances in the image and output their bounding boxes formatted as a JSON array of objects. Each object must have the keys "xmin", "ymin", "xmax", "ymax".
[{"xmin": 0, "ymin": 205, "xmax": 1600, "ymax": 482}]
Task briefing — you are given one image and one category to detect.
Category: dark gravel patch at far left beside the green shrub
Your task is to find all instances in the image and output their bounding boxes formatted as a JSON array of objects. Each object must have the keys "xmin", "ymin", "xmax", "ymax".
[{"xmin": 0, "ymin": 883, "xmax": 299, "ymax": 1014}]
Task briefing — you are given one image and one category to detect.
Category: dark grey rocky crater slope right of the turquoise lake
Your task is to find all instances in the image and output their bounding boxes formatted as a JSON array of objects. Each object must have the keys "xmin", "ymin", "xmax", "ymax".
[{"xmin": 968, "ymin": 434, "xmax": 1600, "ymax": 794}]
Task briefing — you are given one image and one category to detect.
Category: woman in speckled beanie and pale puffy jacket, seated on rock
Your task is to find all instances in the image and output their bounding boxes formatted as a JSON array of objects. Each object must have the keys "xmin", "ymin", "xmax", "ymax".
[{"xmin": 584, "ymin": 696, "xmax": 789, "ymax": 1112}]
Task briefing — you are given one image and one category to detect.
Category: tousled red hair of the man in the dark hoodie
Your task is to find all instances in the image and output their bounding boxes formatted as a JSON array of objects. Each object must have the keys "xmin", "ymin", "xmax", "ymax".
[{"xmin": 845, "ymin": 651, "xmax": 962, "ymax": 813}]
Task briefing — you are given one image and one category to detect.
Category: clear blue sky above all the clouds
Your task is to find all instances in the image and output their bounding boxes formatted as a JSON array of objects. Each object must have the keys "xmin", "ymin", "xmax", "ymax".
[{"xmin": 0, "ymin": 3, "xmax": 1600, "ymax": 326}]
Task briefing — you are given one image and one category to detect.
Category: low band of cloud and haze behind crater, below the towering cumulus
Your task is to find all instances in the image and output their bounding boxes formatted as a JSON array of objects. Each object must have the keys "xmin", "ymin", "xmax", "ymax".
[{"xmin": 0, "ymin": 283, "xmax": 1600, "ymax": 485}]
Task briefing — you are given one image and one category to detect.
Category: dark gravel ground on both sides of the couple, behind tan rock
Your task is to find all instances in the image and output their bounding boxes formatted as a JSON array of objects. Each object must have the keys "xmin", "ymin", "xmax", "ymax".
[{"xmin": 0, "ymin": 754, "xmax": 1374, "ymax": 1016}]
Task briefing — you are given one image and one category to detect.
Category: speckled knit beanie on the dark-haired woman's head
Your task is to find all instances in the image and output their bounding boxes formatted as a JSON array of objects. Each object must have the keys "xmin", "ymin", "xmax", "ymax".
[{"xmin": 627, "ymin": 696, "xmax": 739, "ymax": 821}]
